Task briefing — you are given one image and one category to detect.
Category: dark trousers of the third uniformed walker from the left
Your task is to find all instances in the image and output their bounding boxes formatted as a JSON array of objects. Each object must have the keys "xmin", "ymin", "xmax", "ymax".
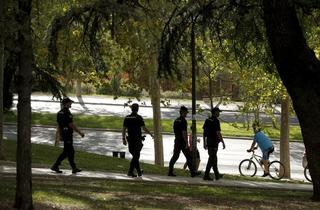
[{"xmin": 169, "ymin": 143, "xmax": 194, "ymax": 175}]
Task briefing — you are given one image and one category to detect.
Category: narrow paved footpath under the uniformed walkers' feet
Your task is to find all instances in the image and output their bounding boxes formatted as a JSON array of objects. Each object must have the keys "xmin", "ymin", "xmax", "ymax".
[{"xmin": 0, "ymin": 163, "xmax": 313, "ymax": 192}]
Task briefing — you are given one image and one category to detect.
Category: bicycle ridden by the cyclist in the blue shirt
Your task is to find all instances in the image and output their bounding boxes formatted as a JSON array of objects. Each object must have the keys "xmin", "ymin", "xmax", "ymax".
[{"xmin": 239, "ymin": 147, "xmax": 285, "ymax": 180}]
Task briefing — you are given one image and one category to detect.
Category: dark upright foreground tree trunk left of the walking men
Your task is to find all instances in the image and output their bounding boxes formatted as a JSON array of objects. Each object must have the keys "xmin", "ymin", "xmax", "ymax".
[{"xmin": 15, "ymin": 0, "xmax": 33, "ymax": 210}]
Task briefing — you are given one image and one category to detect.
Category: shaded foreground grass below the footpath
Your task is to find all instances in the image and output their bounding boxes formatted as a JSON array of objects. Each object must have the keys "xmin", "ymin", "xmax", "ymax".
[{"xmin": 0, "ymin": 175, "xmax": 319, "ymax": 209}]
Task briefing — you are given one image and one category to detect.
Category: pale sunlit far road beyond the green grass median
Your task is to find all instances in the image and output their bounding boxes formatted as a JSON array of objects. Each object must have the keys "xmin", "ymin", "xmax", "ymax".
[{"xmin": 13, "ymin": 94, "xmax": 298, "ymax": 124}]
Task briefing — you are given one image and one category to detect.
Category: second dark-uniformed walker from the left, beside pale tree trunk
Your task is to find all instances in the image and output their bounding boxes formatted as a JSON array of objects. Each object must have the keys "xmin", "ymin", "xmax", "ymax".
[{"xmin": 122, "ymin": 103, "xmax": 153, "ymax": 177}]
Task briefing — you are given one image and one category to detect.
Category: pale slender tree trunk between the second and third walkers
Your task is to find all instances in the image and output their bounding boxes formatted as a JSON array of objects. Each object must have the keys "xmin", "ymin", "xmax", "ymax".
[{"xmin": 150, "ymin": 55, "xmax": 164, "ymax": 166}]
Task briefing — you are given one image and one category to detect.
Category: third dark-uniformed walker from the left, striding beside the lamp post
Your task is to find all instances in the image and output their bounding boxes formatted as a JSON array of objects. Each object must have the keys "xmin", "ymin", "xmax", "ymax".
[{"xmin": 168, "ymin": 106, "xmax": 201, "ymax": 177}]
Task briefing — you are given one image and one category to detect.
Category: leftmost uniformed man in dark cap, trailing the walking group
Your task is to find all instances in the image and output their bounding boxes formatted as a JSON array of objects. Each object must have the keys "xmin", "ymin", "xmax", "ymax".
[{"xmin": 51, "ymin": 98, "xmax": 84, "ymax": 174}]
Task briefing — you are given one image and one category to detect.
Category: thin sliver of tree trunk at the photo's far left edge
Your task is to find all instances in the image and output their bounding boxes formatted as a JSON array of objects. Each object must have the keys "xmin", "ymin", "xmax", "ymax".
[{"xmin": 0, "ymin": 1, "xmax": 5, "ymax": 160}]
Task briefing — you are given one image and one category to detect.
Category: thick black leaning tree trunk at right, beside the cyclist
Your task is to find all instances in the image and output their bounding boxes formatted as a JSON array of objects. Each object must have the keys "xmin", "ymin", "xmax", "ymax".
[{"xmin": 263, "ymin": 0, "xmax": 320, "ymax": 201}]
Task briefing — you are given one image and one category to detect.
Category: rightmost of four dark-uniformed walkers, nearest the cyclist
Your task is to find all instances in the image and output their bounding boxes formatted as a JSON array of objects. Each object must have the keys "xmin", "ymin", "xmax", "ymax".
[{"xmin": 203, "ymin": 107, "xmax": 226, "ymax": 180}]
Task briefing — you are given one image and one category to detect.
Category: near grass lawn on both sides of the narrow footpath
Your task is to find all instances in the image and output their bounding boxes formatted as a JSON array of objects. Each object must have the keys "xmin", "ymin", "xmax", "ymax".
[{"xmin": 0, "ymin": 140, "xmax": 319, "ymax": 210}]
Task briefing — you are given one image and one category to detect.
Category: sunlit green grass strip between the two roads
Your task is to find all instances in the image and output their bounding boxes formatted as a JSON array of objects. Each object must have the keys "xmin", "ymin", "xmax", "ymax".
[{"xmin": 4, "ymin": 112, "xmax": 302, "ymax": 140}]
